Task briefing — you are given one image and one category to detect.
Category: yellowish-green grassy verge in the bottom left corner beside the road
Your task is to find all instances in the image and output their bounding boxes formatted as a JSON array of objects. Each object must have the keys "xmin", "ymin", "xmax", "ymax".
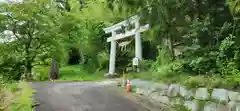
[{"xmin": 0, "ymin": 81, "xmax": 35, "ymax": 111}]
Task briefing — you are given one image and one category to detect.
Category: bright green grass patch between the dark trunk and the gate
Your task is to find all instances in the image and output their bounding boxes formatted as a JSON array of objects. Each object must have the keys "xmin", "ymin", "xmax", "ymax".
[{"xmin": 59, "ymin": 65, "xmax": 105, "ymax": 81}]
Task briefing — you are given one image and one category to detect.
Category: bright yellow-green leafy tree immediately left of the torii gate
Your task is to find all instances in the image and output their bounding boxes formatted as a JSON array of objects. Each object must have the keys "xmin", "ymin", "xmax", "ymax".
[{"xmin": 56, "ymin": 0, "xmax": 123, "ymax": 71}]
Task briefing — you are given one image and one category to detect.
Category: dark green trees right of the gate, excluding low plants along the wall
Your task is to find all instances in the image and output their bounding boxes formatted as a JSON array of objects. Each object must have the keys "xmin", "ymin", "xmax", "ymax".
[{"xmin": 108, "ymin": 0, "xmax": 240, "ymax": 74}]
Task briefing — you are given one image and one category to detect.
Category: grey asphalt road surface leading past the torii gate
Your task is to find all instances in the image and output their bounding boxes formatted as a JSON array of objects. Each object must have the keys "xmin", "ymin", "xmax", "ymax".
[{"xmin": 32, "ymin": 82, "xmax": 153, "ymax": 111}]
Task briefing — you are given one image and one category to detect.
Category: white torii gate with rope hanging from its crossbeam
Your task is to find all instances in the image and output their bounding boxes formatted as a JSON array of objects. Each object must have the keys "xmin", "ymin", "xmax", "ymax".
[{"xmin": 104, "ymin": 15, "xmax": 149, "ymax": 75}]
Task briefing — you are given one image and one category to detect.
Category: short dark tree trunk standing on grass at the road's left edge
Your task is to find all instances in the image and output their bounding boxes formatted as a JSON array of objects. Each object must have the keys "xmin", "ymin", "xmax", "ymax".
[{"xmin": 49, "ymin": 57, "xmax": 59, "ymax": 80}]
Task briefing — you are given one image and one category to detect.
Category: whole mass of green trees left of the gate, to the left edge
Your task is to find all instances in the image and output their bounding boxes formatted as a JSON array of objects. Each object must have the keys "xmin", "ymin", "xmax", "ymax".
[{"xmin": 0, "ymin": 0, "xmax": 139, "ymax": 80}]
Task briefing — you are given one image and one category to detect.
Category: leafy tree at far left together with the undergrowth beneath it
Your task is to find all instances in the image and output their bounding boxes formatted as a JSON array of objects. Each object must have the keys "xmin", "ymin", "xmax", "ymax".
[{"xmin": 0, "ymin": 0, "xmax": 65, "ymax": 80}]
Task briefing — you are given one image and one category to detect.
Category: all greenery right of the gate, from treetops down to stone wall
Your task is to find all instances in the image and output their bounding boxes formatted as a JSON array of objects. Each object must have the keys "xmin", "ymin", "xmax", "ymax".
[{"xmin": 108, "ymin": 0, "xmax": 240, "ymax": 88}]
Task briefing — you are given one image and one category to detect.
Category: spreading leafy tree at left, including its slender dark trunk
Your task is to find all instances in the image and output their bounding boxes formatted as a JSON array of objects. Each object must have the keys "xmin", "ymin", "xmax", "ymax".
[{"xmin": 1, "ymin": 0, "xmax": 62, "ymax": 79}]
